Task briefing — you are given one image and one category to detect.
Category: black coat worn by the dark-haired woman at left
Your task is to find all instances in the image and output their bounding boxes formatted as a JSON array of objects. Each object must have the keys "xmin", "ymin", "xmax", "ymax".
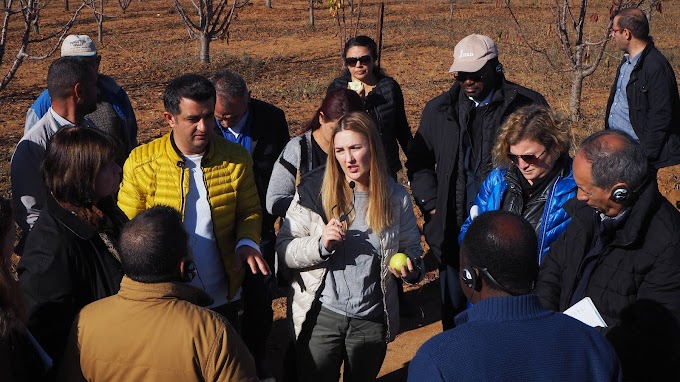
[{"xmin": 17, "ymin": 196, "xmax": 127, "ymax": 362}]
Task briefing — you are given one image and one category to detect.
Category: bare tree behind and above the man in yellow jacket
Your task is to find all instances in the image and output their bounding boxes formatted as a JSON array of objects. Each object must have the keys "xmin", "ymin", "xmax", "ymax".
[{"xmin": 173, "ymin": 0, "xmax": 249, "ymax": 63}]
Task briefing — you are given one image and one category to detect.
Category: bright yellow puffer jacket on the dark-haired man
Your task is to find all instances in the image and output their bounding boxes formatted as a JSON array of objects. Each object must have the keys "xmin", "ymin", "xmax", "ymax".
[{"xmin": 118, "ymin": 133, "xmax": 262, "ymax": 299}]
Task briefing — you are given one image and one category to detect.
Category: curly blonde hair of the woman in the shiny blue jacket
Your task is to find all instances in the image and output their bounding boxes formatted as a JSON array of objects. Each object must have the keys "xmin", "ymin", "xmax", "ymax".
[{"xmin": 493, "ymin": 105, "xmax": 573, "ymax": 168}]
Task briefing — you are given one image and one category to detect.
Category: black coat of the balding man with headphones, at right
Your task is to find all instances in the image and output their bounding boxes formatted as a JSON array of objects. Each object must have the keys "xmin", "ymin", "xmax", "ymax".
[{"xmin": 535, "ymin": 180, "xmax": 680, "ymax": 326}]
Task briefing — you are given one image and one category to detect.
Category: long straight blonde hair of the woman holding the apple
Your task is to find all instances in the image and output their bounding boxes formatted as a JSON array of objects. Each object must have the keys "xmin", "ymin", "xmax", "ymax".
[{"xmin": 321, "ymin": 112, "xmax": 393, "ymax": 233}]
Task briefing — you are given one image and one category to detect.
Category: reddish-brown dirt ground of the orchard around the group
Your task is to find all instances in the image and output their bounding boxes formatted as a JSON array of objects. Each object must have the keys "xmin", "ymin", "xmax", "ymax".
[{"xmin": 0, "ymin": 0, "xmax": 680, "ymax": 381}]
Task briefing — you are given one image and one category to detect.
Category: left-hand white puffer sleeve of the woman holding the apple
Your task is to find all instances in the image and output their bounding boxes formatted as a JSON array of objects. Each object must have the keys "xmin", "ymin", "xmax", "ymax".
[{"xmin": 276, "ymin": 194, "xmax": 326, "ymax": 269}]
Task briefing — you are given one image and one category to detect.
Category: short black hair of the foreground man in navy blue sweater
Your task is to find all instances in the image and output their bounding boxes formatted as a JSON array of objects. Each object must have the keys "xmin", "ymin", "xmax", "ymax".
[{"xmin": 460, "ymin": 211, "xmax": 538, "ymax": 294}]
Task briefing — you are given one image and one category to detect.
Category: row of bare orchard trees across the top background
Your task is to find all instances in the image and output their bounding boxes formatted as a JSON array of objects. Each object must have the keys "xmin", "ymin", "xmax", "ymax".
[{"xmin": 0, "ymin": 0, "xmax": 662, "ymax": 121}]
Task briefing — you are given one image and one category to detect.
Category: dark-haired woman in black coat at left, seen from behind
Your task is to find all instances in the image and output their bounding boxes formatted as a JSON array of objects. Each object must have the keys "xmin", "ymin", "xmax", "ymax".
[{"xmin": 17, "ymin": 127, "xmax": 127, "ymax": 363}]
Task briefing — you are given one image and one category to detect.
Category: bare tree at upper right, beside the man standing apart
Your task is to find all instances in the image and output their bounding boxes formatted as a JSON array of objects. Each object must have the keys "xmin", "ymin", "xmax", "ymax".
[{"xmin": 505, "ymin": 0, "xmax": 661, "ymax": 121}]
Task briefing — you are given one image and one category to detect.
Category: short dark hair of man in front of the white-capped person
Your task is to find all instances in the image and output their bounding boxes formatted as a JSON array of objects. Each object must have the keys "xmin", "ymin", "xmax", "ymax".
[{"xmin": 47, "ymin": 56, "xmax": 96, "ymax": 100}]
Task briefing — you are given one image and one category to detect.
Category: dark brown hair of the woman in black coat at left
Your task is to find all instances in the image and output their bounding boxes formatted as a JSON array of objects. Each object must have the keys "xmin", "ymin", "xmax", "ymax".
[{"xmin": 41, "ymin": 126, "xmax": 118, "ymax": 207}]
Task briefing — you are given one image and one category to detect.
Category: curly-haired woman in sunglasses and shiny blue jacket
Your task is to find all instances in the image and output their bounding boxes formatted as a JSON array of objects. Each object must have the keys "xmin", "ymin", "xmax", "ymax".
[{"xmin": 458, "ymin": 105, "xmax": 576, "ymax": 264}]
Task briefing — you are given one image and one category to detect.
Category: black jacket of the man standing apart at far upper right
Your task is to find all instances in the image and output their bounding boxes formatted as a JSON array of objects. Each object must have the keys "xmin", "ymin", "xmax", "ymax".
[{"xmin": 605, "ymin": 42, "xmax": 680, "ymax": 169}]
